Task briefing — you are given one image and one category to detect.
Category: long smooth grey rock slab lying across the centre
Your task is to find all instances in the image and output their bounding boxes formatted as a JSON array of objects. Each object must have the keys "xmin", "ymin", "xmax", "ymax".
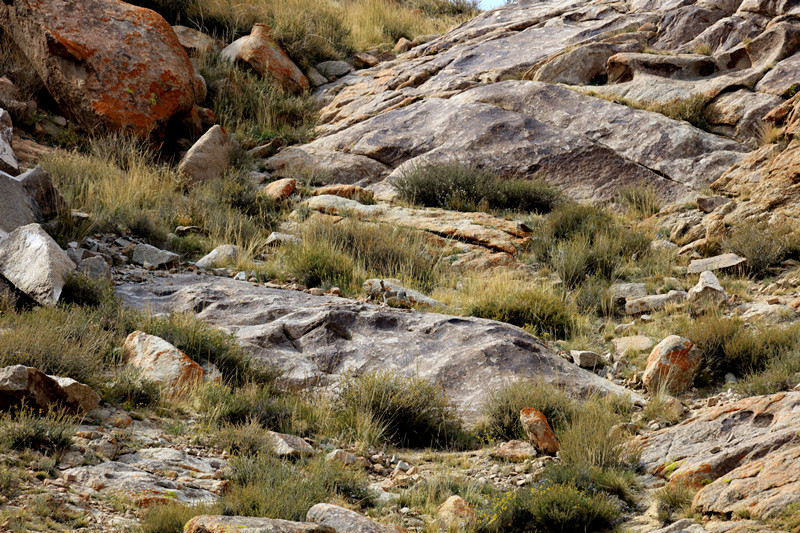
[{"xmin": 118, "ymin": 275, "xmax": 640, "ymax": 420}]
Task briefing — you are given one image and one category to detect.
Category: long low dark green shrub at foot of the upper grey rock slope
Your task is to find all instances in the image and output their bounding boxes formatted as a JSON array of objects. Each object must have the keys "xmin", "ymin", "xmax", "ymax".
[{"xmin": 394, "ymin": 163, "xmax": 561, "ymax": 213}]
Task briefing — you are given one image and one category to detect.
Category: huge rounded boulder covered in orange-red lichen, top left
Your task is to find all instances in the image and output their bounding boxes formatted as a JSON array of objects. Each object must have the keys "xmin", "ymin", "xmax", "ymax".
[{"xmin": 0, "ymin": 0, "xmax": 195, "ymax": 136}]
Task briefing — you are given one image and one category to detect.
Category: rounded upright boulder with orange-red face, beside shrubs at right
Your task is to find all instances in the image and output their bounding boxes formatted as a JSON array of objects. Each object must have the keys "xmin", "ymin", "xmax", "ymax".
[{"xmin": 642, "ymin": 335, "xmax": 703, "ymax": 394}]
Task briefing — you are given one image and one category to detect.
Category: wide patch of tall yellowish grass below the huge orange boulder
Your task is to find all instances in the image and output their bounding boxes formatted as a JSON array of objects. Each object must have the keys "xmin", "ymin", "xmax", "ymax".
[{"xmin": 41, "ymin": 135, "xmax": 279, "ymax": 254}]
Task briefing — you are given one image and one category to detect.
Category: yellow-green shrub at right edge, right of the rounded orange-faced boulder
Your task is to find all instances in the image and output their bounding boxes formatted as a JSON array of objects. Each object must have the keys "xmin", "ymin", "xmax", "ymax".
[{"xmin": 679, "ymin": 314, "xmax": 800, "ymax": 377}]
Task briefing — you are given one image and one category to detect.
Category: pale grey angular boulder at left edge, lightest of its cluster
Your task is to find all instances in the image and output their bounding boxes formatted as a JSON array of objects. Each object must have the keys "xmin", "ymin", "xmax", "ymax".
[{"xmin": 0, "ymin": 224, "xmax": 75, "ymax": 305}]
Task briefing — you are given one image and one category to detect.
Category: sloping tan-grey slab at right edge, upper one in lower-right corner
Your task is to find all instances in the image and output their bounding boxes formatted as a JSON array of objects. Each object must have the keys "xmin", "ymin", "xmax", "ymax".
[{"xmin": 639, "ymin": 392, "xmax": 800, "ymax": 486}]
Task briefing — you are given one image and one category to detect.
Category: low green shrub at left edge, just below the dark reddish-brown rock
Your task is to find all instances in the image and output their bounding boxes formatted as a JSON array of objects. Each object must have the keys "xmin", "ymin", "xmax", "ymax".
[{"xmin": 0, "ymin": 405, "xmax": 78, "ymax": 451}]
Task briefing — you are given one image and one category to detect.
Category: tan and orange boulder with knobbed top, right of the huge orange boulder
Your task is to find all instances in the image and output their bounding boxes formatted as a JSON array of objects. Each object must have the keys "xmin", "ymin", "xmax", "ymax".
[{"xmin": 231, "ymin": 24, "xmax": 310, "ymax": 94}]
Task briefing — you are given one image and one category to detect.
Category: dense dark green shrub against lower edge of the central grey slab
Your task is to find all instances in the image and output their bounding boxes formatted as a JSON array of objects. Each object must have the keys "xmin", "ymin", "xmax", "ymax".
[{"xmin": 339, "ymin": 371, "xmax": 464, "ymax": 448}]
